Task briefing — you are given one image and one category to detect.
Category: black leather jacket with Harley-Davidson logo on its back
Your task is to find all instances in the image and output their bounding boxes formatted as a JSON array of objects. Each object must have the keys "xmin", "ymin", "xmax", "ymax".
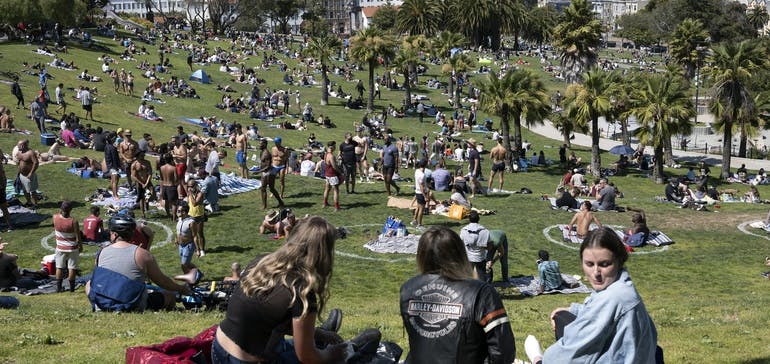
[{"xmin": 401, "ymin": 274, "xmax": 516, "ymax": 364}]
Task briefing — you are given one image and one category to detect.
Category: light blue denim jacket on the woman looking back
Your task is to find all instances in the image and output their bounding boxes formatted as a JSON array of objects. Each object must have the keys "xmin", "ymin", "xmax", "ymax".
[{"xmin": 543, "ymin": 269, "xmax": 658, "ymax": 364}]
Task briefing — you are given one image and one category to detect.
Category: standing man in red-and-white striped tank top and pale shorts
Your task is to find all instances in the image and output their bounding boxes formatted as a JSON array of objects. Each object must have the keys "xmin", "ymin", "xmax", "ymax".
[{"xmin": 53, "ymin": 200, "xmax": 83, "ymax": 292}]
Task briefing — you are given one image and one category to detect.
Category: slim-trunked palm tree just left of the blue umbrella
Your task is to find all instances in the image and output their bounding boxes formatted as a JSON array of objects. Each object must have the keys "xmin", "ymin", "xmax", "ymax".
[{"xmin": 565, "ymin": 69, "xmax": 619, "ymax": 177}]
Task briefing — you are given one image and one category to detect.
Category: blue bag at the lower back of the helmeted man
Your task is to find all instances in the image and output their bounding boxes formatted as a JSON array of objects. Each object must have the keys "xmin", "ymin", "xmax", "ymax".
[{"xmin": 88, "ymin": 266, "xmax": 146, "ymax": 311}]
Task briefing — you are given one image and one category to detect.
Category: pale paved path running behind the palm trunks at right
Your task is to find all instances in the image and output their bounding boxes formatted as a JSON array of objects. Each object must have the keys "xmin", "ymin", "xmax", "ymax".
[{"xmin": 529, "ymin": 121, "xmax": 770, "ymax": 171}]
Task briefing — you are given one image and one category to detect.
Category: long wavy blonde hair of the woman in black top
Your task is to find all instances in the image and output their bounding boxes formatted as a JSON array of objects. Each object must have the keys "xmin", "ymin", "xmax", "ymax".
[{"xmin": 241, "ymin": 216, "xmax": 337, "ymax": 317}]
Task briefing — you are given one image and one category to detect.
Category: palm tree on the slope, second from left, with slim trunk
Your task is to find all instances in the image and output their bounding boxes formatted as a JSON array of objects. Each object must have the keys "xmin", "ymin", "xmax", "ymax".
[{"xmin": 350, "ymin": 27, "xmax": 395, "ymax": 112}]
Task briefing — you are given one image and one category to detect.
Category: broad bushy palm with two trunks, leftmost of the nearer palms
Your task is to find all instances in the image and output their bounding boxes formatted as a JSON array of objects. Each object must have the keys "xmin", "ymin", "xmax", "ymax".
[{"xmin": 479, "ymin": 70, "xmax": 551, "ymax": 165}]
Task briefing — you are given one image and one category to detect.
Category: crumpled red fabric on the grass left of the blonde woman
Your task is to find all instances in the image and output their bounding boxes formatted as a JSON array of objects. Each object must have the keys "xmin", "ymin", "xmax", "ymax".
[{"xmin": 126, "ymin": 325, "xmax": 218, "ymax": 364}]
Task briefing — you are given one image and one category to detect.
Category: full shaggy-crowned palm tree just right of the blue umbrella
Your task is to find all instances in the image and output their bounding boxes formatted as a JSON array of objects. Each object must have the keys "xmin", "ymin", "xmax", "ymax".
[{"xmin": 631, "ymin": 74, "xmax": 695, "ymax": 183}]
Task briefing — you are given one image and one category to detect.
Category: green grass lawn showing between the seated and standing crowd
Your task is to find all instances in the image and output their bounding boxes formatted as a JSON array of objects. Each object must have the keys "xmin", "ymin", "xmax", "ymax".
[{"xmin": 0, "ymin": 32, "xmax": 770, "ymax": 363}]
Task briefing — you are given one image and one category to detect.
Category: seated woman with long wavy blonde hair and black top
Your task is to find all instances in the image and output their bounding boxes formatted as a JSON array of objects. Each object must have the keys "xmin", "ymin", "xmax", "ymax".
[{"xmin": 211, "ymin": 216, "xmax": 346, "ymax": 364}]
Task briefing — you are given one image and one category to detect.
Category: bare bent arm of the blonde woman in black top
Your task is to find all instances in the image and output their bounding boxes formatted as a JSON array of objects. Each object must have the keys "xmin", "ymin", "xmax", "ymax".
[{"xmin": 291, "ymin": 313, "xmax": 347, "ymax": 364}]
